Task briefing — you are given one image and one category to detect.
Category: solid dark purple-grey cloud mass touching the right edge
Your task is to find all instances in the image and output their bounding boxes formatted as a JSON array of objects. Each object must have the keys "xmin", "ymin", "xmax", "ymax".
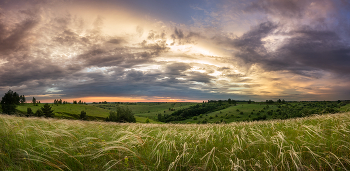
[{"xmin": 267, "ymin": 29, "xmax": 350, "ymax": 75}]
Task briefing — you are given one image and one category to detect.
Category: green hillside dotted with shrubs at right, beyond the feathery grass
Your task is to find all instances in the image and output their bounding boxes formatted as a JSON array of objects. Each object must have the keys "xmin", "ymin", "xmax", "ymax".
[{"xmin": 176, "ymin": 102, "xmax": 350, "ymax": 123}]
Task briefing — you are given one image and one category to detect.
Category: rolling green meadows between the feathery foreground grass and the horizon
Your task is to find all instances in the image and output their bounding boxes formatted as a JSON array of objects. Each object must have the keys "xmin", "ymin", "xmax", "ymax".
[{"xmin": 17, "ymin": 101, "xmax": 350, "ymax": 123}]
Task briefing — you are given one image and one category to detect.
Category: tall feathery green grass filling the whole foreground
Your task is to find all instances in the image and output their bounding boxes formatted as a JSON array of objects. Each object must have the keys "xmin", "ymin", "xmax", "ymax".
[{"xmin": 0, "ymin": 113, "xmax": 350, "ymax": 170}]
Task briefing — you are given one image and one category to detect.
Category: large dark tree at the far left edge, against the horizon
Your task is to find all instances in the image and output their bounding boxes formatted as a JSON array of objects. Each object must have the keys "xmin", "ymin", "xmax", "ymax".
[{"xmin": 1, "ymin": 90, "xmax": 20, "ymax": 114}]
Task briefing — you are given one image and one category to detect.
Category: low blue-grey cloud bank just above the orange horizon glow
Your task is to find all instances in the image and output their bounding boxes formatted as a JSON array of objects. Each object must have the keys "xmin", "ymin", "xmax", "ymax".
[{"xmin": 58, "ymin": 66, "xmax": 226, "ymax": 99}]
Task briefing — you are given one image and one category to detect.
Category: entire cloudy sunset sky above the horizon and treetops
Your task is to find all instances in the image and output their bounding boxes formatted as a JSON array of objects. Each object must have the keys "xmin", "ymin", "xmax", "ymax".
[{"xmin": 0, "ymin": 0, "xmax": 350, "ymax": 102}]
